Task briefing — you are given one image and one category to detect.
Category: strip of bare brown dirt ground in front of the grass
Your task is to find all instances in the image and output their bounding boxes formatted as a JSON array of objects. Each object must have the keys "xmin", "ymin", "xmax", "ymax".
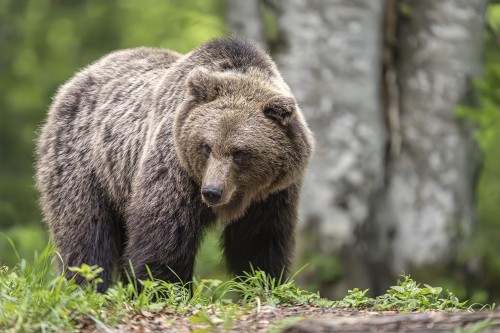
[{"xmin": 84, "ymin": 306, "xmax": 500, "ymax": 333}]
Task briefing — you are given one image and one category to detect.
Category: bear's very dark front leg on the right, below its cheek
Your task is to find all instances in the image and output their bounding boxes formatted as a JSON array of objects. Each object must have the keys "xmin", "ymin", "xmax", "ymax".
[{"xmin": 223, "ymin": 185, "xmax": 299, "ymax": 278}]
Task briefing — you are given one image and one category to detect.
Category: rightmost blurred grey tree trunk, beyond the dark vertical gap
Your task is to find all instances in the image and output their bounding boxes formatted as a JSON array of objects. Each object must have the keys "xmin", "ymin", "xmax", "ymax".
[{"xmin": 378, "ymin": 0, "xmax": 488, "ymax": 273}]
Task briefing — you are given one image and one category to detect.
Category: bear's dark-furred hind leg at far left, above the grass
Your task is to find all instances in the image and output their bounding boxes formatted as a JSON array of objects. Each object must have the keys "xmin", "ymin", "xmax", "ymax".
[{"xmin": 43, "ymin": 169, "xmax": 124, "ymax": 292}]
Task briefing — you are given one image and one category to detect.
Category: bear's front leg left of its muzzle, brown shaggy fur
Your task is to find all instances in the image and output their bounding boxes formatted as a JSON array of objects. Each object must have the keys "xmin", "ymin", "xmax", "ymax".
[{"xmin": 123, "ymin": 170, "xmax": 213, "ymax": 283}]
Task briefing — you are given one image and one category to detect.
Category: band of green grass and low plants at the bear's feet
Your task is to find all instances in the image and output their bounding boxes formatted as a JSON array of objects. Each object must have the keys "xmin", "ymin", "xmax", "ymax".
[{"xmin": 0, "ymin": 246, "xmax": 492, "ymax": 332}]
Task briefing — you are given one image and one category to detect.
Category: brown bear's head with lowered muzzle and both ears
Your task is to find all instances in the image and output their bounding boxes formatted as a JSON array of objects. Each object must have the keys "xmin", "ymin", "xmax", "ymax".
[{"xmin": 174, "ymin": 69, "xmax": 313, "ymax": 222}]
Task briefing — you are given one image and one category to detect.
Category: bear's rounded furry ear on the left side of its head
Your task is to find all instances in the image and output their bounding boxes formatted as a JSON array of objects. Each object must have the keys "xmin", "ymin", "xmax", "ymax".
[{"xmin": 187, "ymin": 68, "xmax": 220, "ymax": 103}]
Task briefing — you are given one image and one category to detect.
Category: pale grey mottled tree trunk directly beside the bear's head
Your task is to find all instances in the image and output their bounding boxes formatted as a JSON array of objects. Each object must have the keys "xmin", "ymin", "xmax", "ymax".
[{"xmin": 278, "ymin": 0, "xmax": 386, "ymax": 296}]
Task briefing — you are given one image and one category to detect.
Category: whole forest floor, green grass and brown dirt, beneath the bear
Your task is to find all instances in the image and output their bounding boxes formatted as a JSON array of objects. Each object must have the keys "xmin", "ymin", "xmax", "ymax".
[{"xmin": 4, "ymin": 255, "xmax": 500, "ymax": 333}]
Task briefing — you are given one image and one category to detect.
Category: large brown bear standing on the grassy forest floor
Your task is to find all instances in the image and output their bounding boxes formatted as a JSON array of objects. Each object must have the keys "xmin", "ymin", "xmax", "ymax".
[{"xmin": 36, "ymin": 38, "xmax": 313, "ymax": 291}]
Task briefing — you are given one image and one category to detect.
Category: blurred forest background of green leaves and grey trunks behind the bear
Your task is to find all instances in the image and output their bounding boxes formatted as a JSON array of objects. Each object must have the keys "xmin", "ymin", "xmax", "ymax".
[{"xmin": 0, "ymin": 0, "xmax": 500, "ymax": 302}]
